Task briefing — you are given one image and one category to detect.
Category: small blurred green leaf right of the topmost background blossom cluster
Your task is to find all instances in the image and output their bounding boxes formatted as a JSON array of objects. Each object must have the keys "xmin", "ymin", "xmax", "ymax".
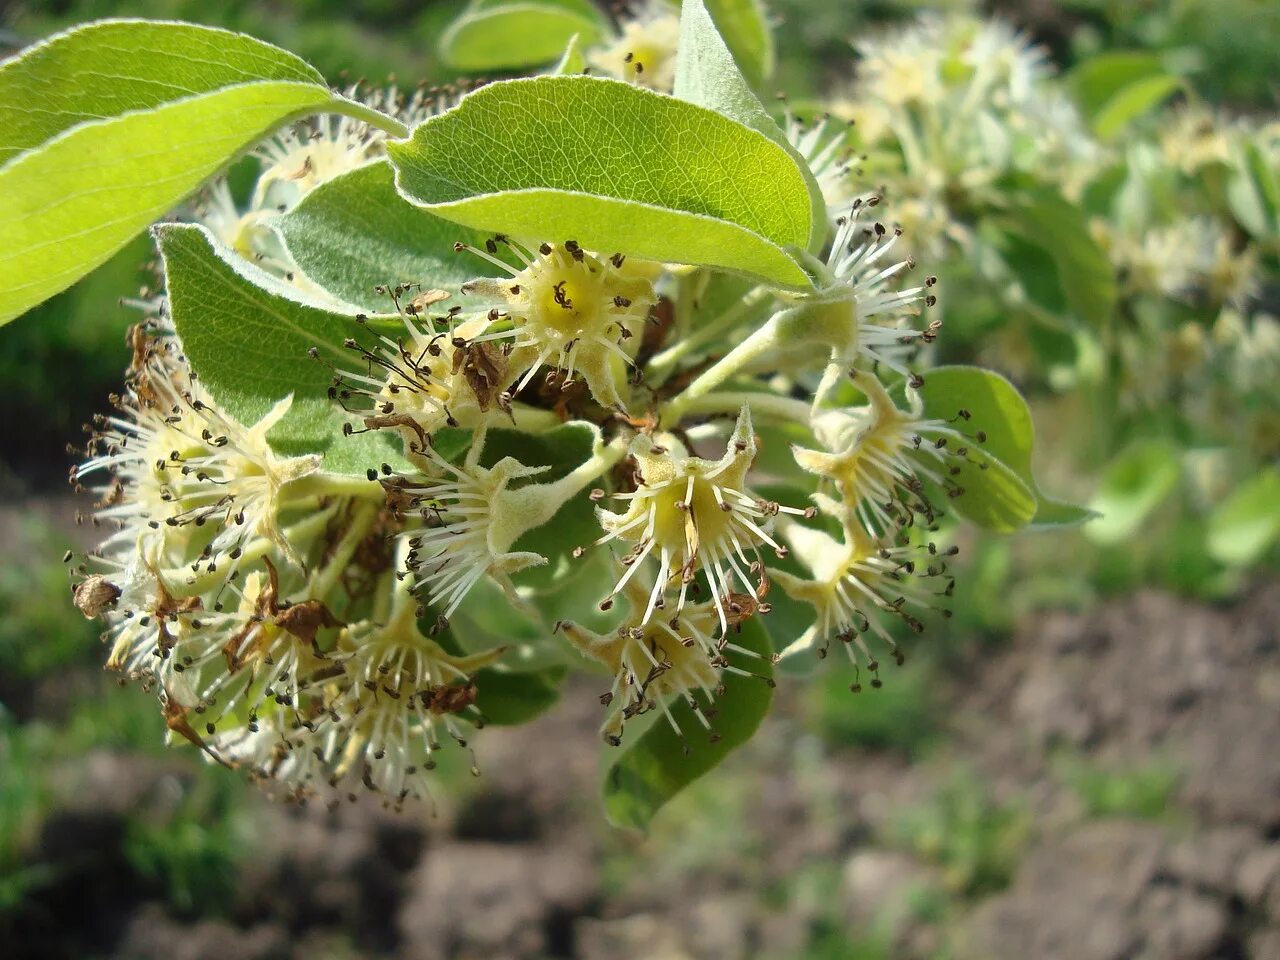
[{"xmin": 1068, "ymin": 50, "xmax": 1181, "ymax": 140}]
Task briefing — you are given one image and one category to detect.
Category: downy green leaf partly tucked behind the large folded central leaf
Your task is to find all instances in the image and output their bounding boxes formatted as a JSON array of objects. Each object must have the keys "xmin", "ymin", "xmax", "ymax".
[{"xmin": 273, "ymin": 161, "xmax": 504, "ymax": 312}]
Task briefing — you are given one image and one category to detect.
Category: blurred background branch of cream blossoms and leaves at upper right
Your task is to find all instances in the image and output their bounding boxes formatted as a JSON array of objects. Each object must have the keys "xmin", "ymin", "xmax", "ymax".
[{"xmin": 819, "ymin": 13, "xmax": 1280, "ymax": 564}]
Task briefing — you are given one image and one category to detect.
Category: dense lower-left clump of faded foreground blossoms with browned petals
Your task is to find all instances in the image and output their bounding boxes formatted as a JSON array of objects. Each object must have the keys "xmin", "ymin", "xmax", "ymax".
[{"xmin": 72, "ymin": 321, "xmax": 500, "ymax": 799}]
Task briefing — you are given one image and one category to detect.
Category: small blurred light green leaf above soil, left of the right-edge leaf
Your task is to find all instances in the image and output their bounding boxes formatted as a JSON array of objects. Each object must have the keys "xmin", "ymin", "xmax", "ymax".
[{"xmin": 1085, "ymin": 440, "xmax": 1181, "ymax": 544}]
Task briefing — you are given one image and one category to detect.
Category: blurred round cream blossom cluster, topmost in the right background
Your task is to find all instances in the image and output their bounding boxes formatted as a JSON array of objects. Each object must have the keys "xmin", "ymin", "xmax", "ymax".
[{"xmin": 832, "ymin": 14, "xmax": 1096, "ymax": 260}]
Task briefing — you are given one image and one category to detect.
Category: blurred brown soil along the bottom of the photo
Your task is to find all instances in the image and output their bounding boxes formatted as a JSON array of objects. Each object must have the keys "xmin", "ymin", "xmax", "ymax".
[{"xmin": 10, "ymin": 584, "xmax": 1280, "ymax": 960}]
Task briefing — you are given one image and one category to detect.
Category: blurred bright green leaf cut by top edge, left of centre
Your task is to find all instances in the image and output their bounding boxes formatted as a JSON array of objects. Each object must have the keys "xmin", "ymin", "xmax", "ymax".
[{"xmin": 439, "ymin": 0, "xmax": 605, "ymax": 73}]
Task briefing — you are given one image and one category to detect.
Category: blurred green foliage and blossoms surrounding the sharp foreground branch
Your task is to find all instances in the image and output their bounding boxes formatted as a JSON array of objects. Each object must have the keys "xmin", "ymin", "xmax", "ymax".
[{"xmin": 0, "ymin": 0, "xmax": 1280, "ymax": 960}]
